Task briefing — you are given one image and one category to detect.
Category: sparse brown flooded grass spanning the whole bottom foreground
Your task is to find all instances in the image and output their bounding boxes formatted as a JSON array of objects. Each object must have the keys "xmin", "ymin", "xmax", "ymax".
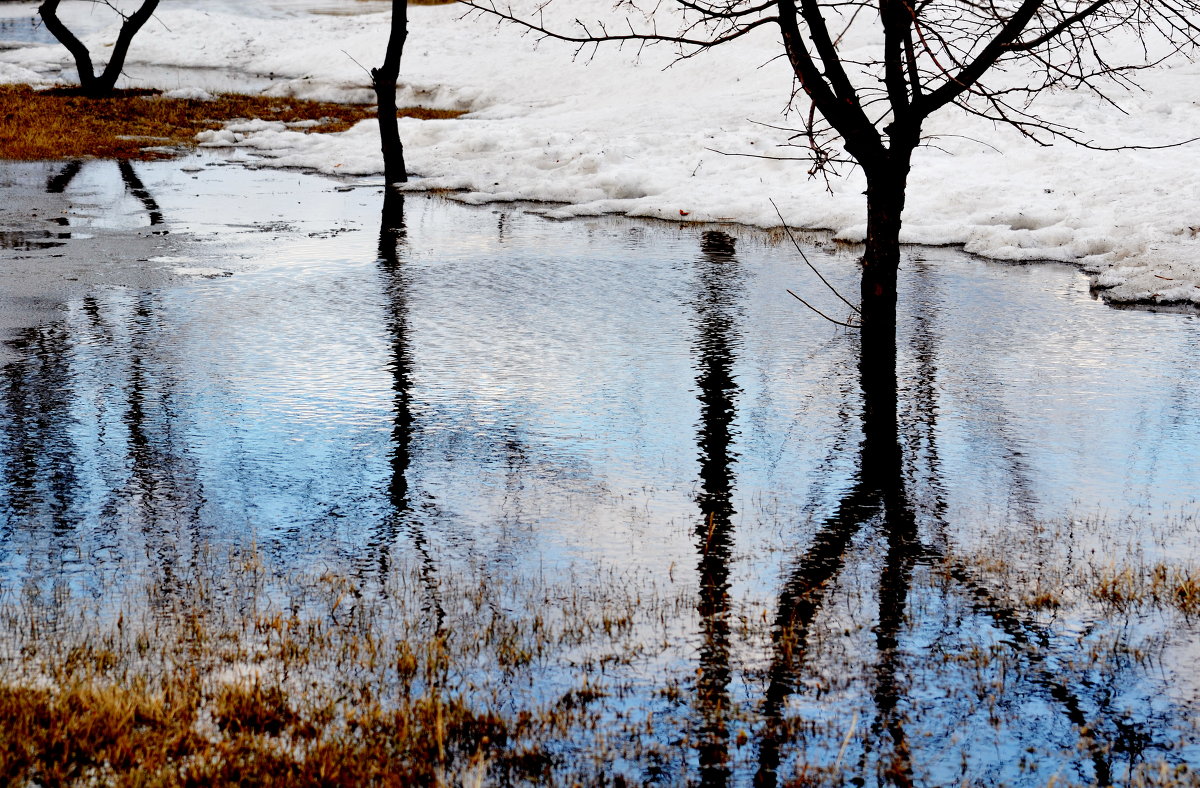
[{"xmin": 0, "ymin": 515, "xmax": 1200, "ymax": 788}]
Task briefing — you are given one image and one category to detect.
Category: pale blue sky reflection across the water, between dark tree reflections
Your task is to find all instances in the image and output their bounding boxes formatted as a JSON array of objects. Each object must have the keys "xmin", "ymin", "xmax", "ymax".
[{"xmin": 0, "ymin": 158, "xmax": 1200, "ymax": 780}]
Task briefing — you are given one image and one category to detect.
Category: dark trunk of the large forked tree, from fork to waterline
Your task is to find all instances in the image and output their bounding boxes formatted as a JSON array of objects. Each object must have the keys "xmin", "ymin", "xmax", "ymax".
[{"xmin": 860, "ymin": 147, "xmax": 911, "ymax": 347}]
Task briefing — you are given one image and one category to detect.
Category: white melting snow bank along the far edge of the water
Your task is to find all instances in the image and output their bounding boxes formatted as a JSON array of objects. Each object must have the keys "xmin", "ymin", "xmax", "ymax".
[{"xmin": 0, "ymin": 0, "xmax": 1200, "ymax": 306}]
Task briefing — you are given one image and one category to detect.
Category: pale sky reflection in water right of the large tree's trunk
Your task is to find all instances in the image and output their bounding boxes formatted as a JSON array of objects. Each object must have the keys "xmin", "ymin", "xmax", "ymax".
[{"xmin": 902, "ymin": 254, "xmax": 1200, "ymax": 534}]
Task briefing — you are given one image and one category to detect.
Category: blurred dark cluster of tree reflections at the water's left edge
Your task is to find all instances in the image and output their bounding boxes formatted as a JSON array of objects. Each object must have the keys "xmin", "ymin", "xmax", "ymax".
[{"xmin": 0, "ymin": 294, "xmax": 203, "ymax": 591}]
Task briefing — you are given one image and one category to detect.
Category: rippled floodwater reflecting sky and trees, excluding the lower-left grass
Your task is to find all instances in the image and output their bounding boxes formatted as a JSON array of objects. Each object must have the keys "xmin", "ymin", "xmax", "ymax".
[{"xmin": 0, "ymin": 160, "xmax": 1200, "ymax": 784}]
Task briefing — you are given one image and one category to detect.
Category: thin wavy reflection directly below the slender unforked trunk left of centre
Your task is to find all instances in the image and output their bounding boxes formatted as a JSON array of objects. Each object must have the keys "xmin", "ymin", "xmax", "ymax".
[{"xmin": 371, "ymin": 188, "xmax": 445, "ymax": 628}]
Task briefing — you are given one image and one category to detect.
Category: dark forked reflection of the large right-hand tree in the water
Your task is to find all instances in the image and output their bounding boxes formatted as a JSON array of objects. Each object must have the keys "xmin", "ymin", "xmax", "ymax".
[{"xmin": 755, "ymin": 256, "xmax": 1165, "ymax": 786}]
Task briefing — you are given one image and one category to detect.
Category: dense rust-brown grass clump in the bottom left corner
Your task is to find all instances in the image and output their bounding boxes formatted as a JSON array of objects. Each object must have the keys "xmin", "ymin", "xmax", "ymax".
[{"xmin": 0, "ymin": 675, "xmax": 546, "ymax": 786}]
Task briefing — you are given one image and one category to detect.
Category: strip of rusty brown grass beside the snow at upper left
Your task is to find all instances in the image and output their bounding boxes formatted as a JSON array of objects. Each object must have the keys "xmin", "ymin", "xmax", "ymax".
[{"xmin": 0, "ymin": 85, "xmax": 462, "ymax": 161}]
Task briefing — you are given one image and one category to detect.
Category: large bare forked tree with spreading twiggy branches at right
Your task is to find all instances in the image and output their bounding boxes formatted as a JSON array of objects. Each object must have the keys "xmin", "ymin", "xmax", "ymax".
[{"xmin": 463, "ymin": 0, "xmax": 1200, "ymax": 335}]
